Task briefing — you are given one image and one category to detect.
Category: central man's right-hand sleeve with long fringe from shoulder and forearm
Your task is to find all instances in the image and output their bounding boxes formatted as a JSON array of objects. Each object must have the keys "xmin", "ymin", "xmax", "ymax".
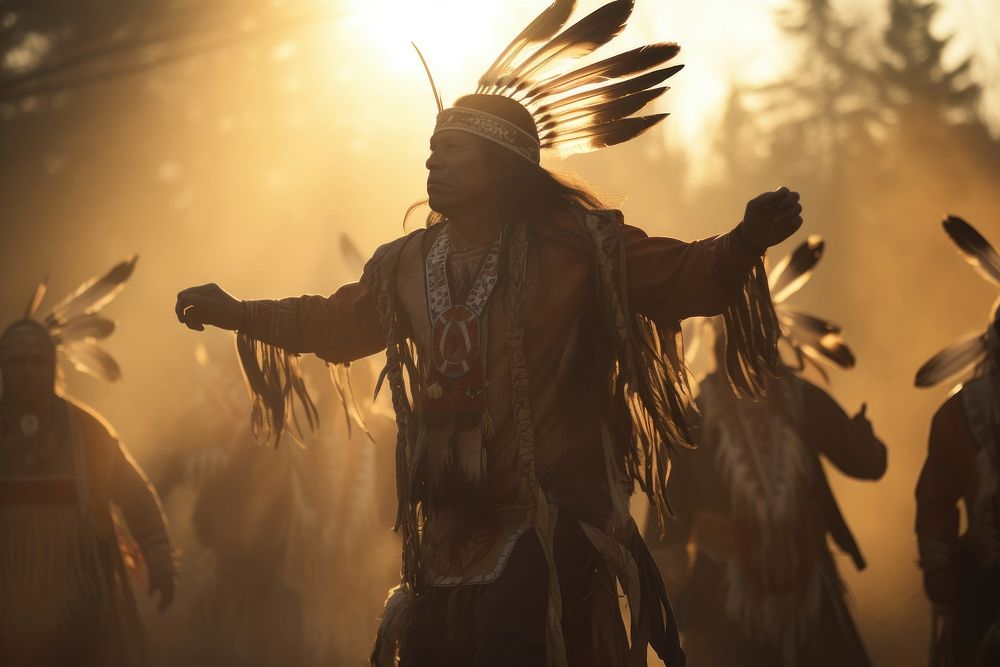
[{"xmin": 584, "ymin": 217, "xmax": 779, "ymax": 530}]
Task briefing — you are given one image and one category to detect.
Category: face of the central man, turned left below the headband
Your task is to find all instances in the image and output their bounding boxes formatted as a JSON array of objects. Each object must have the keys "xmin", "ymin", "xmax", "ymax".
[{"xmin": 427, "ymin": 130, "xmax": 499, "ymax": 215}]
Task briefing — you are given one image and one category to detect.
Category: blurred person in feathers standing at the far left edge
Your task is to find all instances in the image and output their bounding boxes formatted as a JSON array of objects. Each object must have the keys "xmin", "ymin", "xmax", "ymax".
[{"xmin": 0, "ymin": 258, "xmax": 176, "ymax": 667}]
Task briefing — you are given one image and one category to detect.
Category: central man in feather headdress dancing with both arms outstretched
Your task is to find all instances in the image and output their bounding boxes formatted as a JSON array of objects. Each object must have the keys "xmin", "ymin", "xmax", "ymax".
[{"xmin": 176, "ymin": 0, "xmax": 802, "ymax": 667}]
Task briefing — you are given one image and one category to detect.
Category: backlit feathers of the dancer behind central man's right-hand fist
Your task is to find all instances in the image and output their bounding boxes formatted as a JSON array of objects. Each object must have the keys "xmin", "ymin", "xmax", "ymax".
[{"xmin": 767, "ymin": 235, "xmax": 854, "ymax": 379}]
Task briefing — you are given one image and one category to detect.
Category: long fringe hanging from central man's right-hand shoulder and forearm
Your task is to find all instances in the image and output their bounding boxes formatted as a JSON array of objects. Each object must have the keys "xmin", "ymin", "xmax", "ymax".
[{"xmin": 580, "ymin": 211, "xmax": 779, "ymax": 531}]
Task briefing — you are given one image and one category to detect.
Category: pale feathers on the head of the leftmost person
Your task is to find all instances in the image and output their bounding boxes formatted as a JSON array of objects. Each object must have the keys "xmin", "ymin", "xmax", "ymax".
[{"xmin": 4, "ymin": 255, "xmax": 138, "ymax": 382}]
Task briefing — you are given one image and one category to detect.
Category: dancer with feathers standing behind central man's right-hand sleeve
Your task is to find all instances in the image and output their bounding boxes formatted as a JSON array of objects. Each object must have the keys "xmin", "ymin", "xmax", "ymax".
[{"xmin": 647, "ymin": 236, "xmax": 886, "ymax": 667}]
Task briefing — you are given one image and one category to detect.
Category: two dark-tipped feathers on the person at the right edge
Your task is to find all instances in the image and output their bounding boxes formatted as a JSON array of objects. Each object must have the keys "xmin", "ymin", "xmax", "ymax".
[{"xmin": 914, "ymin": 215, "xmax": 1000, "ymax": 387}]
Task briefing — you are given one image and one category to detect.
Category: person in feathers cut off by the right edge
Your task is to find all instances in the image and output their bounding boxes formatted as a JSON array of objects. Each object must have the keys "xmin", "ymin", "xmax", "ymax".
[{"xmin": 915, "ymin": 216, "xmax": 1000, "ymax": 667}]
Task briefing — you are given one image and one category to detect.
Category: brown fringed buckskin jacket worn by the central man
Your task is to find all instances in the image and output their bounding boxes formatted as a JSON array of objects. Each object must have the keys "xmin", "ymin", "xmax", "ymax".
[{"xmin": 240, "ymin": 210, "xmax": 777, "ymax": 666}]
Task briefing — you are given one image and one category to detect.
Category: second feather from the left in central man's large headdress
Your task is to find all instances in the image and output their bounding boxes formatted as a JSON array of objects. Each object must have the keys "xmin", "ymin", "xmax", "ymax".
[{"xmin": 496, "ymin": 0, "xmax": 635, "ymax": 95}]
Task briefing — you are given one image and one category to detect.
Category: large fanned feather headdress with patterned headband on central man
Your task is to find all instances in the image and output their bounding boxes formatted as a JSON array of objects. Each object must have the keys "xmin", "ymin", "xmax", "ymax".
[{"xmin": 421, "ymin": 0, "xmax": 683, "ymax": 164}]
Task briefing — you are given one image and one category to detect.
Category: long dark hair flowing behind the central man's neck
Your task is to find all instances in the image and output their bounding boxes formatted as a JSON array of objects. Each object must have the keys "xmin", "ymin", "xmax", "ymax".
[{"xmin": 418, "ymin": 137, "xmax": 604, "ymax": 227}]
